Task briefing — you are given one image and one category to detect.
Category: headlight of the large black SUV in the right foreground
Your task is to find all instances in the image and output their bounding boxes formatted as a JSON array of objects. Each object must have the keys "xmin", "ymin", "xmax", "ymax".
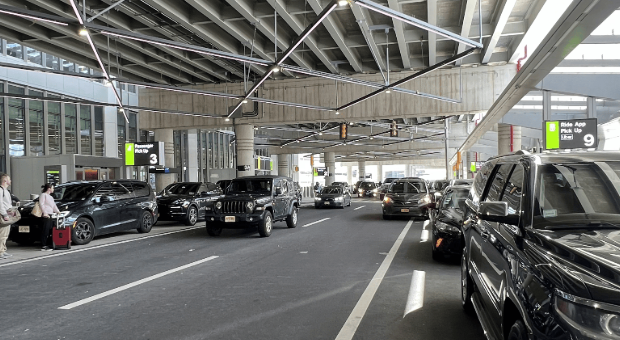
[{"xmin": 555, "ymin": 290, "xmax": 620, "ymax": 339}]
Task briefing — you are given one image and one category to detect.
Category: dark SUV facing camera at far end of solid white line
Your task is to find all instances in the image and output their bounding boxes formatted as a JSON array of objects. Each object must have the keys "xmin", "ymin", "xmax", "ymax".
[{"xmin": 381, "ymin": 178, "xmax": 431, "ymax": 220}]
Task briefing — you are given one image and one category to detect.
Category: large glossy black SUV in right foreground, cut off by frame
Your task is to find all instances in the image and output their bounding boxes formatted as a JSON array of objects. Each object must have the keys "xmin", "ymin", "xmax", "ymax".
[{"xmin": 461, "ymin": 152, "xmax": 620, "ymax": 340}]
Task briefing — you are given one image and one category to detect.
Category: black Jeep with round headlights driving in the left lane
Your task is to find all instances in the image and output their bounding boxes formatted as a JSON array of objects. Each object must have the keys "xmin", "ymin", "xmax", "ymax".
[{"xmin": 207, "ymin": 176, "xmax": 299, "ymax": 237}]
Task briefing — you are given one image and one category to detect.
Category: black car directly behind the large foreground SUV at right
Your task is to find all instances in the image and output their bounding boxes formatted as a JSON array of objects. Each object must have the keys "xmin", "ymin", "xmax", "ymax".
[{"xmin": 430, "ymin": 185, "xmax": 471, "ymax": 260}]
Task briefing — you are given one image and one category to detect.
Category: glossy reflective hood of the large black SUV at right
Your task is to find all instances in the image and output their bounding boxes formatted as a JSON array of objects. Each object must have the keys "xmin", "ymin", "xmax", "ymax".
[{"xmin": 529, "ymin": 229, "xmax": 620, "ymax": 305}]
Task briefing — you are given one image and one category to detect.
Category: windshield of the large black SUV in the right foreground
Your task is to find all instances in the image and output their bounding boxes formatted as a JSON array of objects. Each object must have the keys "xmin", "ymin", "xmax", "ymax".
[{"xmin": 533, "ymin": 162, "xmax": 620, "ymax": 229}]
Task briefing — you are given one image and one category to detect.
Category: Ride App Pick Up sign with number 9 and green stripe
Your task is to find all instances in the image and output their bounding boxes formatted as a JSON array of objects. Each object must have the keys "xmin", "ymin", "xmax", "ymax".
[{"xmin": 545, "ymin": 118, "xmax": 598, "ymax": 150}]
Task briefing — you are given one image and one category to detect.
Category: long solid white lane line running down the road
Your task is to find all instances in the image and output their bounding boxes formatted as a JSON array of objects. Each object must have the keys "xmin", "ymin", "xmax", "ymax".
[{"xmin": 336, "ymin": 220, "xmax": 413, "ymax": 340}]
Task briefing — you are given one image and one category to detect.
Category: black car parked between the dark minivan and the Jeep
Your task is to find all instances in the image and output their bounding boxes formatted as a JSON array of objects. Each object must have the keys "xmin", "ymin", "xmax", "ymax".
[{"xmin": 157, "ymin": 182, "xmax": 223, "ymax": 226}]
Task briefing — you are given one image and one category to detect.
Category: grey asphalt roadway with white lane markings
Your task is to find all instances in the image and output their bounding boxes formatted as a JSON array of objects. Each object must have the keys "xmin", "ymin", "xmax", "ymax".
[{"xmin": 0, "ymin": 200, "xmax": 484, "ymax": 340}]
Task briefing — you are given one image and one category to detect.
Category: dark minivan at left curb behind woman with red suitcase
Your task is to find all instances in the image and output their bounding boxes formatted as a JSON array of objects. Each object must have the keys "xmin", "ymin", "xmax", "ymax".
[{"xmin": 9, "ymin": 180, "xmax": 158, "ymax": 245}]
